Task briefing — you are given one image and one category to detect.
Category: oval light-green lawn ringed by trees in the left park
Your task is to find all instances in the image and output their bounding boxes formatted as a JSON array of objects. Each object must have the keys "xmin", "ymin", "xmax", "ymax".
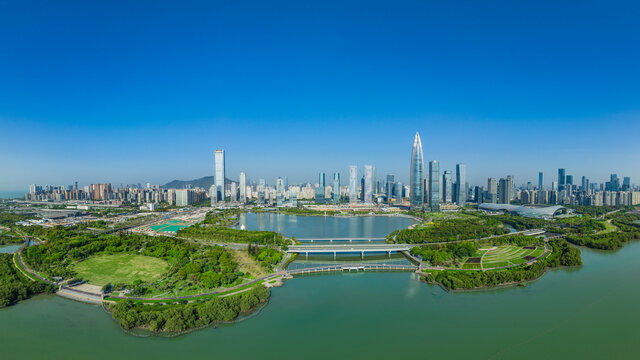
[{"xmin": 73, "ymin": 254, "xmax": 169, "ymax": 286}]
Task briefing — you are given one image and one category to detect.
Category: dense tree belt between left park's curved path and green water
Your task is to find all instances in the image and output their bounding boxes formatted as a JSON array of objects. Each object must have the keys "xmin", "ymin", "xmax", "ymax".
[{"xmin": 110, "ymin": 285, "xmax": 269, "ymax": 332}]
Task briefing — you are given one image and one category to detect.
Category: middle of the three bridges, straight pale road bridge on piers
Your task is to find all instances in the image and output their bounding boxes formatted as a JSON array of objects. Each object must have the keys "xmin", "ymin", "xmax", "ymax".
[{"xmin": 287, "ymin": 244, "xmax": 422, "ymax": 258}]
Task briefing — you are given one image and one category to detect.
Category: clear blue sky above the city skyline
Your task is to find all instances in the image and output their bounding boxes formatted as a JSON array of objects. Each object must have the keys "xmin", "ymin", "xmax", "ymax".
[{"xmin": 0, "ymin": 0, "xmax": 640, "ymax": 191}]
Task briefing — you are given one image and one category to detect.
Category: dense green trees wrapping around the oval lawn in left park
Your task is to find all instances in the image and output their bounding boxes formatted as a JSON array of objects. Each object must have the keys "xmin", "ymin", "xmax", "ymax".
[{"xmin": 24, "ymin": 227, "xmax": 239, "ymax": 293}]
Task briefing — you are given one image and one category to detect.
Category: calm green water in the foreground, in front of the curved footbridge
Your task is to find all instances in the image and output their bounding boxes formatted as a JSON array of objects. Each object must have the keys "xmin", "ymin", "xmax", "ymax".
[{"xmin": 0, "ymin": 215, "xmax": 640, "ymax": 360}]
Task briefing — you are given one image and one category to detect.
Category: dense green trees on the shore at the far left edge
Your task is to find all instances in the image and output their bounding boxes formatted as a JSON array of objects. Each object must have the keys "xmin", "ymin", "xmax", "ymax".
[{"xmin": 0, "ymin": 254, "xmax": 55, "ymax": 308}]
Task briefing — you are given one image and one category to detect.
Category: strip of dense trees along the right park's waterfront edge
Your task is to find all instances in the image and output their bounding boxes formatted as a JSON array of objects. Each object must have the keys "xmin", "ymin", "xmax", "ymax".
[{"xmin": 427, "ymin": 239, "xmax": 582, "ymax": 290}]
